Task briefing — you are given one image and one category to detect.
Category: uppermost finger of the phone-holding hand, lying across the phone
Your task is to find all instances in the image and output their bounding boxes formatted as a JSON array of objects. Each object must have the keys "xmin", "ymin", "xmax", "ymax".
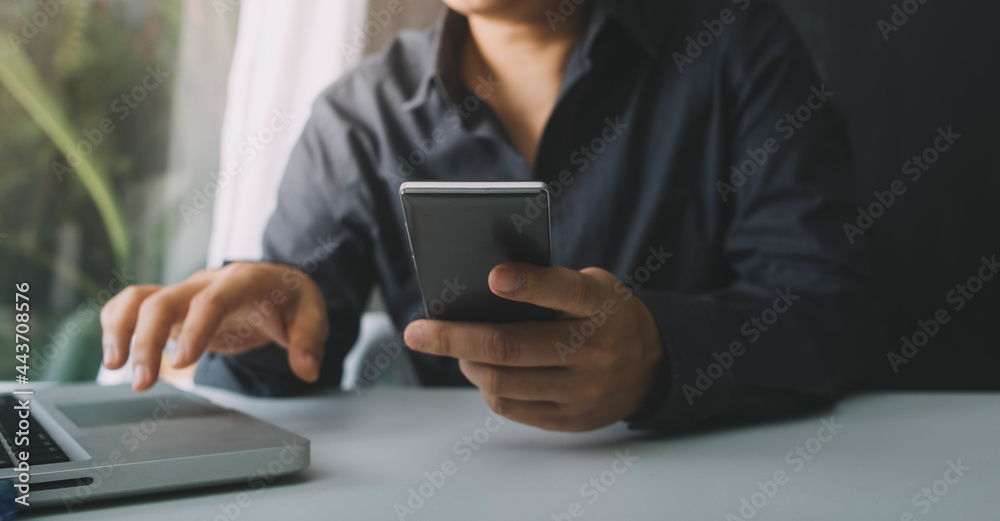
[{"xmin": 489, "ymin": 262, "xmax": 617, "ymax": 317}]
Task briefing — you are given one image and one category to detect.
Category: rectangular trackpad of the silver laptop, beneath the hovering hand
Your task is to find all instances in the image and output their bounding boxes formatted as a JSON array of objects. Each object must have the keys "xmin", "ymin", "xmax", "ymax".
[{"xmin": 58, "ymin": 394, "xmax": 226, "ymax": 429}]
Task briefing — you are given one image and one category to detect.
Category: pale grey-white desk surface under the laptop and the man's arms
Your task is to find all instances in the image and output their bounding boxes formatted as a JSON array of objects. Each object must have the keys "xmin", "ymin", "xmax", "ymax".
[{"xmin": 24, "ymin": 389, "xmax": 1000, "ymax": 521}]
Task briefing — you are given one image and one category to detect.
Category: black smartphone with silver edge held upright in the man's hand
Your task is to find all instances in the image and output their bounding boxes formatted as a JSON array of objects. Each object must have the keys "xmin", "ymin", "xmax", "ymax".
[{"xmin": 399, "ymin": 181, "xmax": 554, "ymax": 322}]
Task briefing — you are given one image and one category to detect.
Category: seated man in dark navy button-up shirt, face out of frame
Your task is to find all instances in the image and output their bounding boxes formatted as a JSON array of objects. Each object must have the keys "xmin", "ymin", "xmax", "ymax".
[{"xmin": 102, "ymin": 0, "xmax": 879, "ymax": 430}]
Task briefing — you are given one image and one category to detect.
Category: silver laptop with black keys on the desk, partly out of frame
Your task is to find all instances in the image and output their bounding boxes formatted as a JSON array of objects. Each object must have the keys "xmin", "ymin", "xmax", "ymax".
[{"xmin": 0, "ymin": 383, "xmax": 309, "ymax": 510}]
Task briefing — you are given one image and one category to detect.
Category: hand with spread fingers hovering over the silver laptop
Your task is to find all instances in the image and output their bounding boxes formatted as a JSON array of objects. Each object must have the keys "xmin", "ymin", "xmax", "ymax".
[{"xmin": 101, "ymin": 262, "xmax": 329, "ymax": 391}]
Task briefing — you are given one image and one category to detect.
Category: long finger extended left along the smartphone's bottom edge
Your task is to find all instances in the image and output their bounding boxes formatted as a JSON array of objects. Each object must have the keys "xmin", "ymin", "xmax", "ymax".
[{"xmin": 403, "ymin": 320, "xmax": 572, "ymax": 367}]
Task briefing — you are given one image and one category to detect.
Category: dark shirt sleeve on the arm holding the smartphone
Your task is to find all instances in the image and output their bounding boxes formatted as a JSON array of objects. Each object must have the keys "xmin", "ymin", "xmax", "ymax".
[{"xmin": 627, "ymin": 2, "xmax": 881, "ymax": 430}]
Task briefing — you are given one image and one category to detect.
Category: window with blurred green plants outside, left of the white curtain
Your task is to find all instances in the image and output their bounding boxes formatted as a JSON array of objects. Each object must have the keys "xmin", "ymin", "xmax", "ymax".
[{"xmin": 0, "ymin": 0, "xmax": 237, "ymax": 380}]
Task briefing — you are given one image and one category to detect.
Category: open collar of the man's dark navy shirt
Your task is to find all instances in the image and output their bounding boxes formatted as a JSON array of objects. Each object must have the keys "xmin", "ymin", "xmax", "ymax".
[{"xmin": 402, "ymin": 0, "xmax": 672, "ymax": 110}]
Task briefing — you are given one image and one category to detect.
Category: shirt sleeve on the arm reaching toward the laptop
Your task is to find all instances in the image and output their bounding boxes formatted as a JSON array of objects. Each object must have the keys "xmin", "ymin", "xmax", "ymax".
[{"xmin": 195, "ymin": 89, "xmax": 375, "ymax": 396}]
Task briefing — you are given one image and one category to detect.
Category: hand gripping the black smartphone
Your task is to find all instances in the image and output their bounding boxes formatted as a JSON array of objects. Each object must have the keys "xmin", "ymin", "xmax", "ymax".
[{"xmin": 403, "ymin": 263, "xmax": 663, "ymax": 431}]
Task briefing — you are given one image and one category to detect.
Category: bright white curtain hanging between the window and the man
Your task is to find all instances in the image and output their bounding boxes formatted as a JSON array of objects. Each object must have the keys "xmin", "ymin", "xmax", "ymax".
[{"xmin": 208, "ymin": 0, "xmax": 365, "ymax": 268}]
